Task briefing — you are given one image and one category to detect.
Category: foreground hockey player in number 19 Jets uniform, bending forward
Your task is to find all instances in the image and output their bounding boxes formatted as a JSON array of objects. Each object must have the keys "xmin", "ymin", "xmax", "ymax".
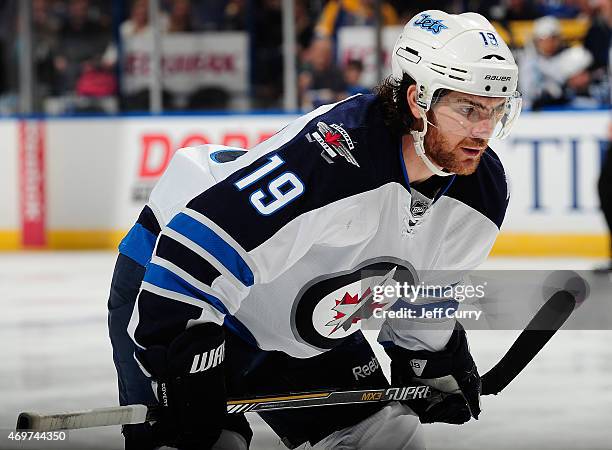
[{"xmin": 109, "ymin": 11, "xmax": 520, "ymax": 449}]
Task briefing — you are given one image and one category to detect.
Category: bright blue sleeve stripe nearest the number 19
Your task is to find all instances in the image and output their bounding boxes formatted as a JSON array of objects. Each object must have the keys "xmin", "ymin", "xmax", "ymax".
[{"xmin": 168, "ymin": 213, "xmax": 254, "ymax": 287}]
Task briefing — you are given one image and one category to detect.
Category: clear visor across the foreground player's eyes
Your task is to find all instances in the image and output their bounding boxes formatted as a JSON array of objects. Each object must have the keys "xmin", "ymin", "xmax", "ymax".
[{"xmin": 427, "ymin": 92, "xmax": 522, "ymax": 139}]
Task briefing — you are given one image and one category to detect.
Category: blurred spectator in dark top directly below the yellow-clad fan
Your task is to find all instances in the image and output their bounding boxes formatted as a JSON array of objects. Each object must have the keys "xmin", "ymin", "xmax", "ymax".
[{"xmin": 298, "ymin": 38, "xmax": 346, "ymax": 110}]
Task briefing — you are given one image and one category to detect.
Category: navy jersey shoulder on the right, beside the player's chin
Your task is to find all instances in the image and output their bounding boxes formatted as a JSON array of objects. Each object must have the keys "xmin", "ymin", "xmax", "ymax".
[{"xmin": 445, "ymin": 148, "xmax": 509, "ymax": 228}]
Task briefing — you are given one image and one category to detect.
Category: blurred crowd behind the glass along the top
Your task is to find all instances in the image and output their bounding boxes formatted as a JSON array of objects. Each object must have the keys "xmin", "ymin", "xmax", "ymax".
[{"xmin": 0, "ymin": 0, "xmax": 612, "ymax": 114}]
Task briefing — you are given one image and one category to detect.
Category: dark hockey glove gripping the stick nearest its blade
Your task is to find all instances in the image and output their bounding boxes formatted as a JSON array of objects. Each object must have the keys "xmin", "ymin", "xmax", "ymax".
[{"xmin": 385, "ymin": 322, "xmax": 481, "ymax": 424}]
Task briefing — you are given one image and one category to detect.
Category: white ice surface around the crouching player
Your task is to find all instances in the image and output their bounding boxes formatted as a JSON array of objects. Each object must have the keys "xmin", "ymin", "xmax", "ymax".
[{"xmin": 0, "ymin": 252, "xmax": 612, "ymax": 449}]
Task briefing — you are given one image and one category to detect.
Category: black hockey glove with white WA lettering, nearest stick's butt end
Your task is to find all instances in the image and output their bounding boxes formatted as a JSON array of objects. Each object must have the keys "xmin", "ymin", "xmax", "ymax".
[{"xmin": 136, "ymin": 323, "xmax": 227, "ymax": 450}]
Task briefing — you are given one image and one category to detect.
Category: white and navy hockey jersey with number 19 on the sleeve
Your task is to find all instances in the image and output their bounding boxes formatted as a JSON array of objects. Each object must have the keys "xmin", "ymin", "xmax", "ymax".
[{"xmin": 120, "ymin": 95, "xmax": 508, "ymax": 358}]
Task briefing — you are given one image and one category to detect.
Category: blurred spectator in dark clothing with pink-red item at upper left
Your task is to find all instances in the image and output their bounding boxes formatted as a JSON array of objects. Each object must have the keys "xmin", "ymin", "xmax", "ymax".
[{"xmin": 53, "ymin": 0, "xmax": 116, "ymax": 96}]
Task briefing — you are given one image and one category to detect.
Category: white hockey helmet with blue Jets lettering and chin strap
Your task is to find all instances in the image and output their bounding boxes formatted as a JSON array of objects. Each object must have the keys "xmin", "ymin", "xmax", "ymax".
[{"xmin": 391, "ymin": 10, "xmax": 521, "ymax": 175}]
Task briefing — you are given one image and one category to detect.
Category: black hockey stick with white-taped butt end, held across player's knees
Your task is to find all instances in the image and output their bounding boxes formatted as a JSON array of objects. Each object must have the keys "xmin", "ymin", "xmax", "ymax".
[{"xmin": 17, "ymin": 291, "xmax": 576, "ymax": 431}]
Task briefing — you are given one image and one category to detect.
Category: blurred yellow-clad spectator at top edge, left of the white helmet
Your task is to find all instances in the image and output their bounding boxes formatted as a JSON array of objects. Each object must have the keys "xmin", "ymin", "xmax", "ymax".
[{"xmin": 315, "ymin": 0, "xmax": 399, "ymax": 43}]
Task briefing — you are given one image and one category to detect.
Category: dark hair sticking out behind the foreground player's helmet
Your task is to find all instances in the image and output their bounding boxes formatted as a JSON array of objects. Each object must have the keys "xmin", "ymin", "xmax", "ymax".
[{"xmin": 374, "ymin": 74, "xmax": 417, "ymax": 136}]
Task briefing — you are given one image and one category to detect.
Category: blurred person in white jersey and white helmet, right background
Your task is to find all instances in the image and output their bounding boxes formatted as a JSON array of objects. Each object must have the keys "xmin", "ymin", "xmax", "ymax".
[{"xmin": 519, "ymin": 16, "xmax": 594, "ymax": 110}]
